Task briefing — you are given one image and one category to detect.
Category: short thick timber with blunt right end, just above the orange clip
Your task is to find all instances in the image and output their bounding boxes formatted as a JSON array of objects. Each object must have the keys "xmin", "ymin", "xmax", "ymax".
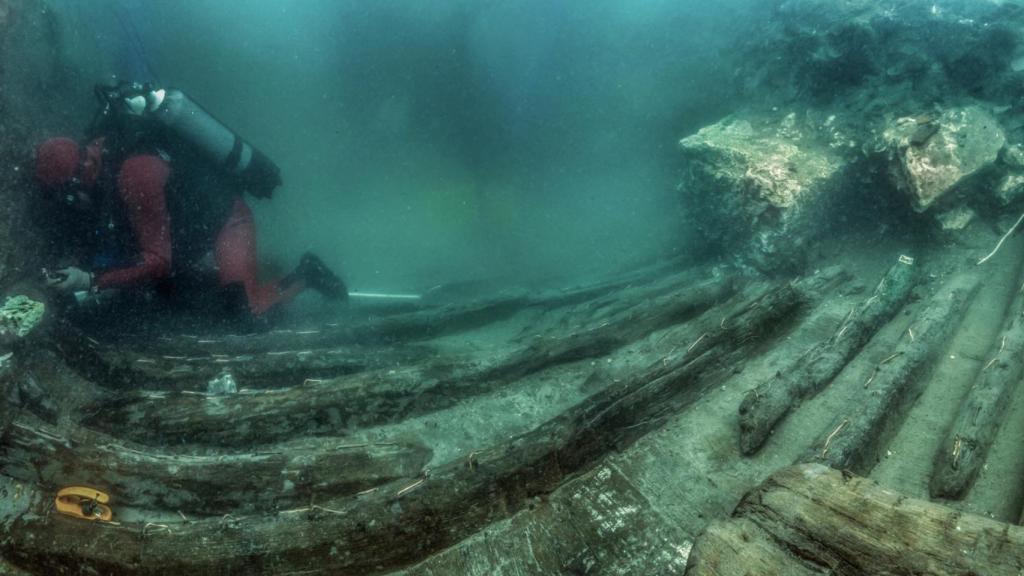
[{"xmin": 0, "ymin": 417, "xmax": 432, "ymax": 516}]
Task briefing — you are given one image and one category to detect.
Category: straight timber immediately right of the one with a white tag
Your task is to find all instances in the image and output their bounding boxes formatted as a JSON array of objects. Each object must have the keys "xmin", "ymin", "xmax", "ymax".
[{"xmin": 804, "ymin": 276, "xmax": 981, "ymax": 474}]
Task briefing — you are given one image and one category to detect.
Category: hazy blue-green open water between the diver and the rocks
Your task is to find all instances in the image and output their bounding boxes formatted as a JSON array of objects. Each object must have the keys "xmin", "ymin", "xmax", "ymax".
[{"xmin": 48, "ymin": 0, "xmax": 743, "ymax": 290}]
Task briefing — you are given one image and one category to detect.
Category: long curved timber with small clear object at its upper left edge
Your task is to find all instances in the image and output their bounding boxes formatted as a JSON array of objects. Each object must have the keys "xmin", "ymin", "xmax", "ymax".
[{"xmin": 83, "ymin": 279, "xmax": 732, "ymax": 446}]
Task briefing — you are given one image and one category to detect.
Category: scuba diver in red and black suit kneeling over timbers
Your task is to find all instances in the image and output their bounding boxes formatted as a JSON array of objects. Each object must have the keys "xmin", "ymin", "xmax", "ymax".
[{"xmin": 36, "ymin": 83, "xmax": 347, "ymax": 318}]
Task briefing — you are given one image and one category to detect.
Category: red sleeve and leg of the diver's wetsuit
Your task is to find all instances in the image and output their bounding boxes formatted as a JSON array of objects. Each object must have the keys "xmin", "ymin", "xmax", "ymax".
[{"xmin": 91, "ymin": 141, "xmax": 304, "ymax": 315}]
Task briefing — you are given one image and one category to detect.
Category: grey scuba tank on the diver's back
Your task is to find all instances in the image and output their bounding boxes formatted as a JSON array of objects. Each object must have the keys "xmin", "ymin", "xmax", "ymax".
[{"xmin": 90, "ymin": 82, "xmax": 282, "ymax": 198}]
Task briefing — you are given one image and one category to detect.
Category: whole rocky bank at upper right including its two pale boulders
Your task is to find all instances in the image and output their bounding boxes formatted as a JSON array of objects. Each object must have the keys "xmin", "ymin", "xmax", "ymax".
[{"xmin": 679, "ymin": 0, "xmax": 1024, "ymax": 273}]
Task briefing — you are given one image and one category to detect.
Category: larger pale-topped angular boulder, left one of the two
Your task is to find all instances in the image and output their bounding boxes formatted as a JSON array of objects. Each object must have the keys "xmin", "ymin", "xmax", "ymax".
[{"xmin": 680, "ymin": 114, "xmax": 844, "ymax": 270}]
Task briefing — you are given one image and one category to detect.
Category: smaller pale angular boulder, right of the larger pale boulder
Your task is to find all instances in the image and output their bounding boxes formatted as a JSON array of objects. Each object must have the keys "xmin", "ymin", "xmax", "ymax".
[{"xmin": 883, "ymin": 106, "xmax": 1007, "ymax": 212}]
